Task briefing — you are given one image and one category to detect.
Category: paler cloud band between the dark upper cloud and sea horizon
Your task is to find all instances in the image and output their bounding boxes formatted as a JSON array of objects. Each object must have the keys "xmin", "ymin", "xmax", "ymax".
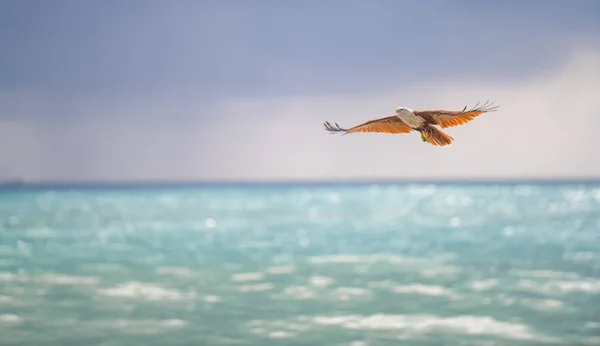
[{"xmin": 0, "ymin": 49, "xmax": 600, "ymax": 181}]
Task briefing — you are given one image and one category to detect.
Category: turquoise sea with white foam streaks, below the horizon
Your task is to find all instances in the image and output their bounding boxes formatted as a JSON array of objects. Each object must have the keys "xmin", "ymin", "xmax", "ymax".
[{"xmin": 0, "ymin": 182, "xmax": 600, "ymax": 346}]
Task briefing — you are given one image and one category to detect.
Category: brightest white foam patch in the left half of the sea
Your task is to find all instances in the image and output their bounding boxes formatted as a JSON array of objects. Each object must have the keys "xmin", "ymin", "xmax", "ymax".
[{"xmin": 99, "ymin": 281, "xmax": 196, "ymax": 300}]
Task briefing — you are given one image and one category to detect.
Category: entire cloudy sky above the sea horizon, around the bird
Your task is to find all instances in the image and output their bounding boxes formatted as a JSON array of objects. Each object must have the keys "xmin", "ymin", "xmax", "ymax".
[{"xmin": 0, "ymin": 0, "xmax": 600, "ymax": 182}]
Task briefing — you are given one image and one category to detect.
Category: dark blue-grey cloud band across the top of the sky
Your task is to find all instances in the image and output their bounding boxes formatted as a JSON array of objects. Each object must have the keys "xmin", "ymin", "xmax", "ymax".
[{"xmin": 0, "ymin": 0, "xmax": 600, "ymax": 98}]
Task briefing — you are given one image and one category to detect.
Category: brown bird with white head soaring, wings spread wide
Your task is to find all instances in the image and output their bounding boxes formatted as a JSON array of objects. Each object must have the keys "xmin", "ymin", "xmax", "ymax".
[{"xmin": 323, "ymin": 101, "xmax": 500, "ymax": 147}]
